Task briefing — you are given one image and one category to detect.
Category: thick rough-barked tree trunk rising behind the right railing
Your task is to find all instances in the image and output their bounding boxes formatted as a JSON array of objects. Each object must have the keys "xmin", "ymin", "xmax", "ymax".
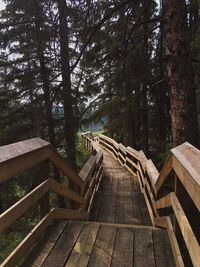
[{"xmin": 164, "ymin": 0, "xmax": 199, "ymax": 147}]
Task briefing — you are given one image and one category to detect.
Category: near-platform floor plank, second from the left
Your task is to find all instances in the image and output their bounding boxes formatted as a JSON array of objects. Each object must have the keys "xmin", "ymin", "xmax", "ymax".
[{"xmin": 42, "ymin": 222, "xmax": 84, "ymax": 267}]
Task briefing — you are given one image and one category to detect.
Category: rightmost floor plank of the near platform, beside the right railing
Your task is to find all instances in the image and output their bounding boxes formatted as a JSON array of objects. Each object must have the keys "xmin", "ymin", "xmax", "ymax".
[{"xmin": 152, "ymin": 230, "xmax": 175, "ymax": 267}]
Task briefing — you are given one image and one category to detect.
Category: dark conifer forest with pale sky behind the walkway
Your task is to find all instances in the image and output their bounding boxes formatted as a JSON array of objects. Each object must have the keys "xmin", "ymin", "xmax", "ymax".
[{"xmin": 0, "ymin": 0, "xmax": 200, "ymax": 258}]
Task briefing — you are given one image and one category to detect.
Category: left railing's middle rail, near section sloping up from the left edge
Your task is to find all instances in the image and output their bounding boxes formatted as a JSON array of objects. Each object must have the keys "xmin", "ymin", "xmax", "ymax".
[{"xmin": 0, "ymin": 179, "xmax": 50, "ymax": 233}]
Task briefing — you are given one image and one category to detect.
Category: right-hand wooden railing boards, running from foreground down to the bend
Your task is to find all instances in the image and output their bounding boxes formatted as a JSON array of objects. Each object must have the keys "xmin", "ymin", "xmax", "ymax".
[{"xmin": 99, "ymin": 134, "xmax": 200, "ymax": 267}]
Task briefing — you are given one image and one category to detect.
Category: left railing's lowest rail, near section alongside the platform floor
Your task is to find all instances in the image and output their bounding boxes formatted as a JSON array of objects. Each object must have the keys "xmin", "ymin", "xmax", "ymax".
[{"xmin": 1, "ymin": 212, "xmax": 53, "ymax": 267}]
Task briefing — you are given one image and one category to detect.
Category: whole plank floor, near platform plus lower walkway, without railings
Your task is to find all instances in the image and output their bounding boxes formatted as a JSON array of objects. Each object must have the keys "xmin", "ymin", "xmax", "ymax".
[{"xmin": 22, "ymin": 151, "xmax": 175, "ymax": 267}]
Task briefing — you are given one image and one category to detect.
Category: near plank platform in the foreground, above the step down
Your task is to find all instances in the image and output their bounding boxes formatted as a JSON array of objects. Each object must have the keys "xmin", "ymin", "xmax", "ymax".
[{"xmin": 22, "ymin": 221, "xmax": 175, "ymax": 267}]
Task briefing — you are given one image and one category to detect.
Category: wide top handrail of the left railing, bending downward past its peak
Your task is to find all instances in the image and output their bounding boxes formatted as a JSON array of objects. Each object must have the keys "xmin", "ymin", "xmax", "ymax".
[{"xmin": 0, "ymin": 138, "xmax": 83, "ymax": 188}]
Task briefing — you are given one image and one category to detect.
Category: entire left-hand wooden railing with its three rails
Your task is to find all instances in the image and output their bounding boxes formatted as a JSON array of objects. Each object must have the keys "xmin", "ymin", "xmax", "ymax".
[{"xmin": 0, "ymin": 138, "xmax": 103, "ymax": 267}]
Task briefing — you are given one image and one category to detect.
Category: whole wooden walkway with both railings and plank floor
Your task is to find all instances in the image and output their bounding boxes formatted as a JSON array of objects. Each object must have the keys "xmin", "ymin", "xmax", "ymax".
[{"xmin": 0, "ymin": 133, "xmax": 200, "ymax": 267}]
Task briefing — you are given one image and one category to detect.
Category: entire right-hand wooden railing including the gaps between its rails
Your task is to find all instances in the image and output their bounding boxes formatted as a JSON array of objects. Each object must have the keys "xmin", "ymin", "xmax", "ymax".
[{"xmin": 95, "ymin": 135, "xmax": 200, "ymax": 267}]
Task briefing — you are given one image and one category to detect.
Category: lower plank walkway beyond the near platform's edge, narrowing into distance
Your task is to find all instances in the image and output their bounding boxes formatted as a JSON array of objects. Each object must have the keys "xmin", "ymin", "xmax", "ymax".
[{"xmin": 90, "ymin": 151, "xmax": 151, "ymax": 225}]
